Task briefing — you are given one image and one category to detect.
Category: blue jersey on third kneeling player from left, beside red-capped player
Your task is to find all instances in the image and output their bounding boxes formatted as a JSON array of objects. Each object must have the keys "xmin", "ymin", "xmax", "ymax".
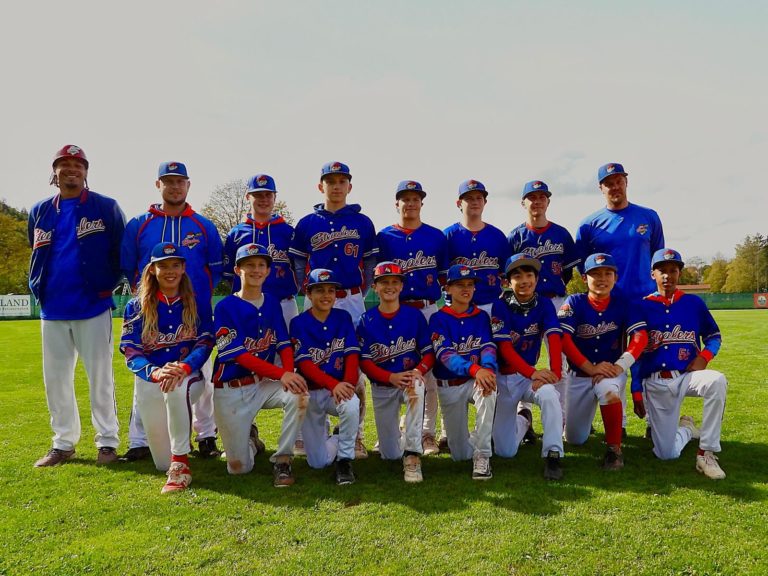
[{"xmin": 289, "ymin": 308, "xmax": 360, "ymax": 389}]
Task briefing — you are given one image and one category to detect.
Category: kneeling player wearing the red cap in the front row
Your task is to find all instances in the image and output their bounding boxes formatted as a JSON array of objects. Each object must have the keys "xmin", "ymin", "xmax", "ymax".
[{"xmin": 357, "ymin": 262, "xmax": 435, "ymax": 482}]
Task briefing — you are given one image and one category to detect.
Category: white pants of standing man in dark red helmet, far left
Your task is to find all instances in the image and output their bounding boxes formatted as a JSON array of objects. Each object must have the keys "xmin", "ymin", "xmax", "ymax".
[{"xmin": 40, "ymin": 310, "xmax": 120, "ymax": 451}]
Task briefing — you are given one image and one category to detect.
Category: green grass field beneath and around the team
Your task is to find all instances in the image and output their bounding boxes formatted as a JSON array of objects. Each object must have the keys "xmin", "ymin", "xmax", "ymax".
[{"xmin": 0, "ymin": 311, "xmax": 768, "ymax": 576}]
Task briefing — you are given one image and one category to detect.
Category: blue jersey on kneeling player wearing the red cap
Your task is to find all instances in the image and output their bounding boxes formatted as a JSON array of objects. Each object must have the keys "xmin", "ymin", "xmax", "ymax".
[{"xmin": 357, "ymin": 306, "xmax": 432, "ymax": 380}]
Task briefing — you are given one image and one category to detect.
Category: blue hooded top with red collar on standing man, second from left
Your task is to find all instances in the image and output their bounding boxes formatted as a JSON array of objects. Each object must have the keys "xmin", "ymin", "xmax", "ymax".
[{"xmin": 120, "ymin": 204, "xmax": 223, "ymax": 308}]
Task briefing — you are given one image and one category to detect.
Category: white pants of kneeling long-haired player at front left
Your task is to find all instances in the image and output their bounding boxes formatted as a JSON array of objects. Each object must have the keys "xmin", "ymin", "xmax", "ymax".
[{"xmin": 134, "ymin": 372, "xmax": 205, "ymax": 471}]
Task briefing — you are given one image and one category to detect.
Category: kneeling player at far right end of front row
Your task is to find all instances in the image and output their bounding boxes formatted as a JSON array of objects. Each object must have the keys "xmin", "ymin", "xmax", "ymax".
[{"xmin": 632, "ymin": 249, "xmax": 728, "ymax": 480}]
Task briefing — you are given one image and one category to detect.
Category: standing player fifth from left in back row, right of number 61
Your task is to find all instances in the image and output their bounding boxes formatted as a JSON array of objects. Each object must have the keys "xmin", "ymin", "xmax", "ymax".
[{"xmin": 376, "ymin": 180, "xmax": 448, "ymax": 456}]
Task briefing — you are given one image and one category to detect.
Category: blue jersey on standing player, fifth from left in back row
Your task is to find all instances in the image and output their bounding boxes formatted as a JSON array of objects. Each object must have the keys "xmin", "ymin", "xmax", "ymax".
[{"xmin": 376, "ymin": 224, "xmax": 448, "ymax": 301}]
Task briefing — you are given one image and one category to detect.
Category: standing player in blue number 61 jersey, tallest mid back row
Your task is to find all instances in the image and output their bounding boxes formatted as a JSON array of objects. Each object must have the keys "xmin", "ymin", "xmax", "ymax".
[{"xmin": 290, "ymin": 162, "xmax": 378, "ymax": 459}]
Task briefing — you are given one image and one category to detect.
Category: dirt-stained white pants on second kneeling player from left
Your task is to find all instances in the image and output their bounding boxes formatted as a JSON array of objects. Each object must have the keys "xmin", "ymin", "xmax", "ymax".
[{"xmin": 213, "ymin": 378, "xmax": 309, "ymax": 474}]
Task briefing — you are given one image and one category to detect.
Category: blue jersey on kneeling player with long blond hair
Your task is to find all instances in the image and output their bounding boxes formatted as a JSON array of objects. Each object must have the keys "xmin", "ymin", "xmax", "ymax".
[{"xmin": 120, "ymin": 296, "xmax": 213, "ymax": 382}]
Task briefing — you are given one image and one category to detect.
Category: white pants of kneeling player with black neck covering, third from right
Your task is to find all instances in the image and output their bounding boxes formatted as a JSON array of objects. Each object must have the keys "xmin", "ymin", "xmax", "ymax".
[{"xmin": 493, "ymin": 374, "xmax": 565, "ymax": 458}]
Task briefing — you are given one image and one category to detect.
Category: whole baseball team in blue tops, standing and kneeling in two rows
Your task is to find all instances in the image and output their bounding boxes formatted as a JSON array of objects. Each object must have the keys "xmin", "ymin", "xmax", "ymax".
[{"xmin": 28, "ymin": 145, "xmax": 727, "ymax": 493}]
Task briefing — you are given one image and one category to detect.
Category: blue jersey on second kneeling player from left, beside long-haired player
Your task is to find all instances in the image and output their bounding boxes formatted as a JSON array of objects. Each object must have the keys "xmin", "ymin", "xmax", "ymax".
[{"xmin": 213, "ymin": 294, "xmax": 291, "ymax": 382}]
